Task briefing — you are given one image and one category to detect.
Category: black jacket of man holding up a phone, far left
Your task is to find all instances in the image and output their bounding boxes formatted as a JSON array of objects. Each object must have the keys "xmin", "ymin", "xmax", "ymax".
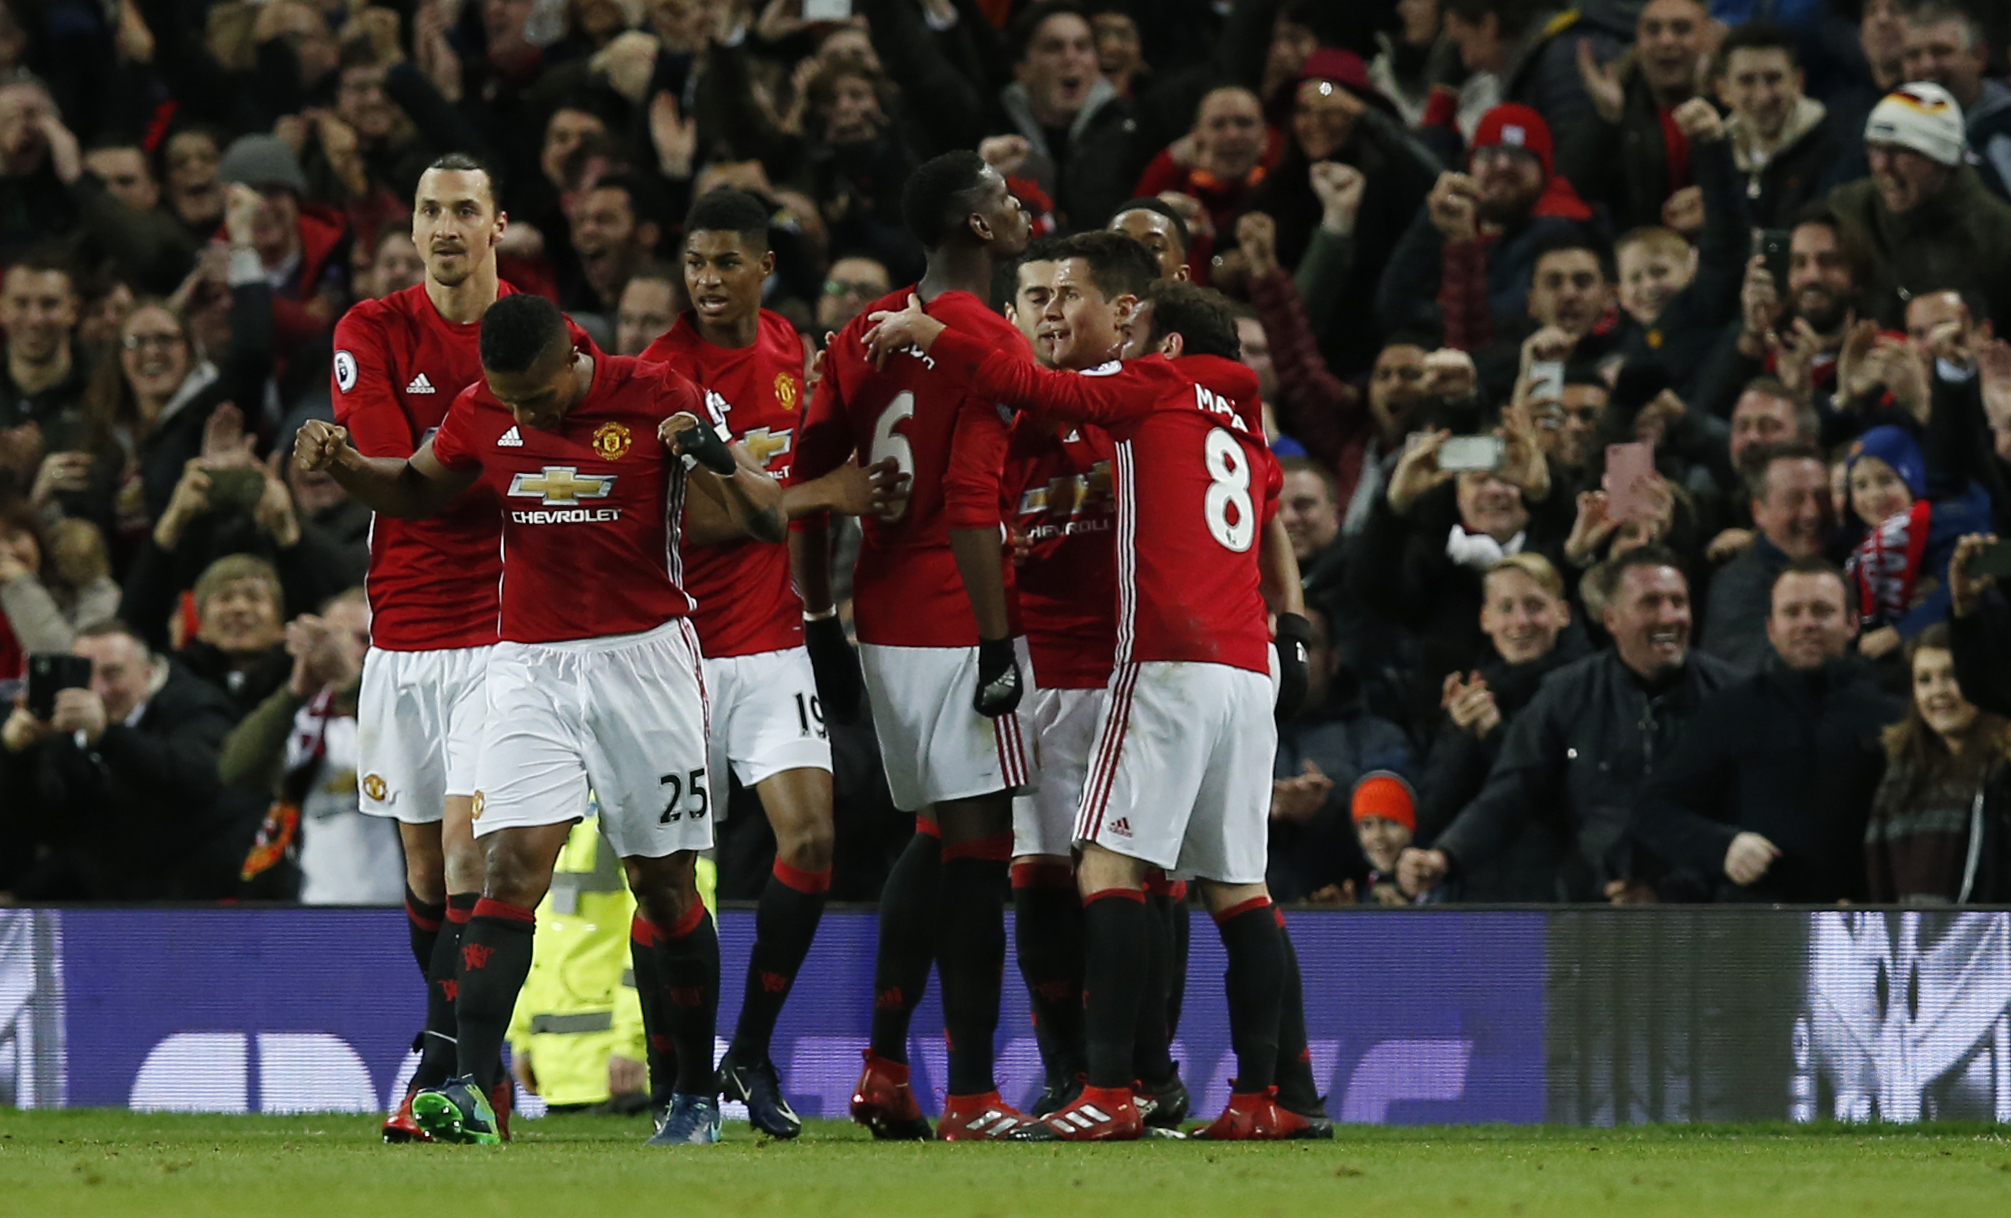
[{"xmin": 0, "ymin": 667, "xmax": 249, "ymax": 900}]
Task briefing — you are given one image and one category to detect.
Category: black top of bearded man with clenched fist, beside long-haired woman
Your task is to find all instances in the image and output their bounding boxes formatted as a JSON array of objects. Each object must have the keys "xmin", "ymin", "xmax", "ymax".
[{"xmin": 1633, "ymin": 657, "xmax": 1906, "ymax": 904}]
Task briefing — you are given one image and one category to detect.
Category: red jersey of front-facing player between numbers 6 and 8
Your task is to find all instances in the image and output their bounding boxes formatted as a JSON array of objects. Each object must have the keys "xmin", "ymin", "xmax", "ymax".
[{"xmin": 1006, "ymin": 414, "xmax": 1118, "ymax": 689}]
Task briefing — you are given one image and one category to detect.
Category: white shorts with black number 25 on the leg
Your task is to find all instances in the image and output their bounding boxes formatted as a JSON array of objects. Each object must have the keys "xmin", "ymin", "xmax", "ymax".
[{"xmin": 475, "ymin": 617, "xmax": 712, "ymax": 858}]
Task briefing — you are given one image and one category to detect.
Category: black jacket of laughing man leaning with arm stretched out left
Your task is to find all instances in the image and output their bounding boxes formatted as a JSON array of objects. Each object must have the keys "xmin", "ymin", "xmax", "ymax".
[{"xmin": 1436, "ymin": 649, "xmax": 1738, "ymax": 900}]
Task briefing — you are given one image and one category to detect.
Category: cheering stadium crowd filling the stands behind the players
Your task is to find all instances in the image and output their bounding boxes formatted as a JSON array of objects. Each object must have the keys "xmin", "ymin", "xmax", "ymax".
[{"xmin": 0, "ymin": 0, "xmax": 2011, "ymax": 904}]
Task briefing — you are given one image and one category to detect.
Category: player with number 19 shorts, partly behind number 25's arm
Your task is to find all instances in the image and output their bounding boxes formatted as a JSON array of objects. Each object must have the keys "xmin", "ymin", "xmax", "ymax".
[{"xmin": 642, "ymin": 189, "xmax": 849, "ymax": 1138}]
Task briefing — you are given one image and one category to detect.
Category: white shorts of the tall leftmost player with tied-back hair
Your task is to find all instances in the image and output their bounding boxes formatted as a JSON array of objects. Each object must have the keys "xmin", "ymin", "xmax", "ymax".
[{"xmin": 356, "ymin": 647, "xmax": 493, "ymax": 824}]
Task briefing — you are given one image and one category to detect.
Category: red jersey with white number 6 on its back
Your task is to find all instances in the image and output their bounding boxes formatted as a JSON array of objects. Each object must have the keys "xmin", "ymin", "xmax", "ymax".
[{"xmin": 794, "ymin": 285, "xmax": 1032, "ymax": 647}]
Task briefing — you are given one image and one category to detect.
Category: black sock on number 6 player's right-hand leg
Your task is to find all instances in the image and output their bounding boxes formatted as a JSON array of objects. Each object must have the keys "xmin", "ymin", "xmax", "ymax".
[{"xmin": 937, "ymin": 832, "xmax": 1012, "ymax": 1095}]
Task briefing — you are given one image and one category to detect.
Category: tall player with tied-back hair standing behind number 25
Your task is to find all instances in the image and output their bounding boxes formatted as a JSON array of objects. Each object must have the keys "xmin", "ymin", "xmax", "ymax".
[{"xmin": 332, "ymin": 153, "xmax": 559, "ymax": 1142}]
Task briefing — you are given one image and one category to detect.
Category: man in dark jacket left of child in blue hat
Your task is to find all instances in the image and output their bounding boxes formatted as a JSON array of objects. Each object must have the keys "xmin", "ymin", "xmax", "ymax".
[{"xmin": 1703, "ymin": 444, "xmax": 1832, "ymax": 673}]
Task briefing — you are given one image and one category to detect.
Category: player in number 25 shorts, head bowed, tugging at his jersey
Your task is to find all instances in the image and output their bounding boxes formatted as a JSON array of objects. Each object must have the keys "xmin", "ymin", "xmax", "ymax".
[{"xmin": 298, "ymin": 295, "xmax": 784, "ymax": 1144}]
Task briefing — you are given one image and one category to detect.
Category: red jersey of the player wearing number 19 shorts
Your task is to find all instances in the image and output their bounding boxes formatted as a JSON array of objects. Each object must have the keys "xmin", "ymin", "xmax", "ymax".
[{"xmin": 642, "ymin": 310, "xmax": 802, "ymax": 657}]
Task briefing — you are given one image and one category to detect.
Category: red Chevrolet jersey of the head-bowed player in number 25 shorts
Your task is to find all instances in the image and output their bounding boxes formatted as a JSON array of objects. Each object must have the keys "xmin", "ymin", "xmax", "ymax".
[{"xmin": 432, "ymin": 348, "xmax": 718, "ymax": 643}]
